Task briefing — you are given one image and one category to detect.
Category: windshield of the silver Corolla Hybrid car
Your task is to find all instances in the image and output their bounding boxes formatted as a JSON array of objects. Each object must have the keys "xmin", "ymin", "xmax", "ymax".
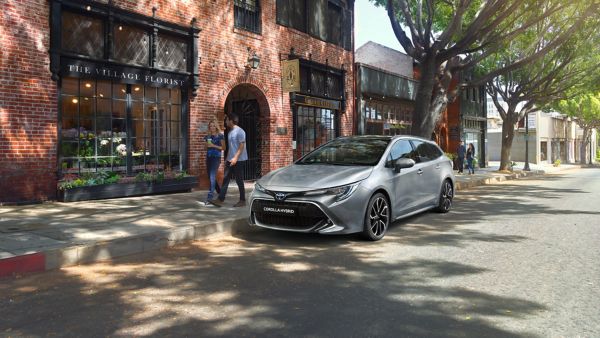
[{"xmin": 296, "ymin": 137, "xmax": 390, "ymax": 166}]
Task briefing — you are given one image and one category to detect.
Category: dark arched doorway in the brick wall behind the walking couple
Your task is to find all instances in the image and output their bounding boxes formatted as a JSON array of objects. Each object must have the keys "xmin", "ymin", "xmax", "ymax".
[{"xmin": 224, "ymin": 84, "xmax": 268, "ymax": 180}]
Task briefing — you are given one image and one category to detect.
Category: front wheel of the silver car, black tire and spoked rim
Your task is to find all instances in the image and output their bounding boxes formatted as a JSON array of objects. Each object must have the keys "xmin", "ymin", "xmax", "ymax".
[{"xmin": 363, "ymin": 193, "xmax": 391, "ymax": 241}]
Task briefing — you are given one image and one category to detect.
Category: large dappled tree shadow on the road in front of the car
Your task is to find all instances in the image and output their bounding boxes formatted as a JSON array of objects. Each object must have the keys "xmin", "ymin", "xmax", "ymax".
[{"xmin": 0, "ymin": 220, "xmax": 545, "ymax": 337}]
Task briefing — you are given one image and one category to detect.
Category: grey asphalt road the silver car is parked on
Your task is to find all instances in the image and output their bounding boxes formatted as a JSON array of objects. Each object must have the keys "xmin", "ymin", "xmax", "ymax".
[{"xmin": 0, "ymin": 169, "xmax": 600, "ymax": 337}]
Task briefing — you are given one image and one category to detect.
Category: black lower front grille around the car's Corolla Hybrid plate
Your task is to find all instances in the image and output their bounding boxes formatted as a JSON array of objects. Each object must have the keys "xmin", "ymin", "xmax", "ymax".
[{"xmin": 252, "ymin": 200, "xmax": 328, "ymax": 229}]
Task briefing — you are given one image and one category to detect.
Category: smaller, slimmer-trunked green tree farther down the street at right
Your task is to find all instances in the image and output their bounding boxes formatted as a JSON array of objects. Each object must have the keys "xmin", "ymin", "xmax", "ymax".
[{"xmin": 479, "ymin": 13, "xmax": 600, "ymax": 170}]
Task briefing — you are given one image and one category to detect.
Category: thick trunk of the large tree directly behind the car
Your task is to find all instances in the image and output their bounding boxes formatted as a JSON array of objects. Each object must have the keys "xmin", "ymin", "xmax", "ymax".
[{"xmin": 411, "ymin": 57, "xmax": 437, "ymax": 139}]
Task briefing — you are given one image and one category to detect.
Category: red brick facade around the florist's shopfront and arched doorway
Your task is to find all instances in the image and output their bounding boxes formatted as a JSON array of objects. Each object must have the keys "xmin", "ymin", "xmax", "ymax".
[{"xmin": 0, "ymin": 0, "xmax": 354, "ymax": 202}]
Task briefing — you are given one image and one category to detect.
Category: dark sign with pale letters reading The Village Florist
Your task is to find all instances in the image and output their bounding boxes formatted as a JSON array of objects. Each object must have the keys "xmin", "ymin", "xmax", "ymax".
[{"xmin": 62, "ymin": 60, "xmax": 188, "ymax": 88}]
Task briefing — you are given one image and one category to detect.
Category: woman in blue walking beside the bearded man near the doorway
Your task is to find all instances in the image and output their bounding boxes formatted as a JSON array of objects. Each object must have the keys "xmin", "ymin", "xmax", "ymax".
[{"xmin": 204, "ymin": 119, "xmax": 225, "ymax": 205}]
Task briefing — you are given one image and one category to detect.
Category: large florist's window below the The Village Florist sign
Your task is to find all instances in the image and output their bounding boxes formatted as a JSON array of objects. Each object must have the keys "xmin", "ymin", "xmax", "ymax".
[{"xmin": 60, "ymin": 78, "xmax": 183, "ymax": 174}]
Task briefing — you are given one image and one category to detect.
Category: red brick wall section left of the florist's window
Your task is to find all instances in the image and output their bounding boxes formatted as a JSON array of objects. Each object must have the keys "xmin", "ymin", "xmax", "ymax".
[{"xmin": 0, "ymin": 0, "xmax": 57, "ymax": 203}]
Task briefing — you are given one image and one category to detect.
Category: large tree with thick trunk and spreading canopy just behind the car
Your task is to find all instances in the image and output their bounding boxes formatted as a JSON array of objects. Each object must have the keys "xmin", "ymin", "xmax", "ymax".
[{"xmin": 371, "ymin": 0, "xmax": 600, "ymax": 137}]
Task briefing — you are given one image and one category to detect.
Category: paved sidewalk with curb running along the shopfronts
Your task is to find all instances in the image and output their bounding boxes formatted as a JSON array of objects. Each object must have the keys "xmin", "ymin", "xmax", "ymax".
[{"xmin": 0, "ymin": 162, "xmax": 579, "ymax": 278}]
